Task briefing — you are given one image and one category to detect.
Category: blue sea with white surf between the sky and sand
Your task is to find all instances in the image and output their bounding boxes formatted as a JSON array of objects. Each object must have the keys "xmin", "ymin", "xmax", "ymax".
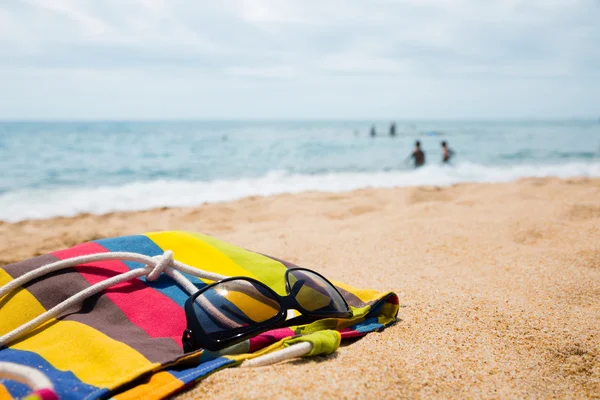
[{"xmin": 0, "ymin": 120, "xmax": 600, "ymax": 222}]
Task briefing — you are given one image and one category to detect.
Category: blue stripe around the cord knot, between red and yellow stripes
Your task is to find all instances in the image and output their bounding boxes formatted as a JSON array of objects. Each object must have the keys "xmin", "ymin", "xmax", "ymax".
[{"xmin": 95, "ymin": 235, "xmax": 206, "ymax": 308}]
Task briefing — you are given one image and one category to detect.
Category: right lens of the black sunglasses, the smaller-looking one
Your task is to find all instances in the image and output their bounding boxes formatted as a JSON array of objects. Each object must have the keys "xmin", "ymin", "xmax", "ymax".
[{"xmin": 288, "ymin": 270, "xmax": 349, "ymax": 314}]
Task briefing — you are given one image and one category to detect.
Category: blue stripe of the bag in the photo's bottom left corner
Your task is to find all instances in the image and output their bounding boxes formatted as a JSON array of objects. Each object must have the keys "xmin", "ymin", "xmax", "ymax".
[{"xmin": 0, "ymin": 348, "xmax": 103, "ymax": 399}]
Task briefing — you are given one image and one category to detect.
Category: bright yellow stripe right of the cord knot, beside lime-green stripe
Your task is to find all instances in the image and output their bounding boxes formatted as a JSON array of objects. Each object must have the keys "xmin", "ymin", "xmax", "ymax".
[{"xmin": 146, "ymin": 231, "xmax": 258, "ymax": 282}]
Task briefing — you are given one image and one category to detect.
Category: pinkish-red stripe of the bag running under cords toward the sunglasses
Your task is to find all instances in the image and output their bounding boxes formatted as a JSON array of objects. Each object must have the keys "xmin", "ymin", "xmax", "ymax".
[{"xmin": 52, "ymin": 242, "xmax": 186, "ymax": 347}]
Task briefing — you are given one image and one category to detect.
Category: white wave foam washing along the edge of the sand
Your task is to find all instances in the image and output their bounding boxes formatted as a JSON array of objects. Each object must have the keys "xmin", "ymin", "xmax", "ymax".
[{"xmin": 0, "ymin": 163, "xmax": 600, "ymax": 222}]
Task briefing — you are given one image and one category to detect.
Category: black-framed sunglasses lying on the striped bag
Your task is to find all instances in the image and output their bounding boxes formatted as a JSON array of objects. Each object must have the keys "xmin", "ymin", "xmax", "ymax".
[{"xmin": 182, "ymin": 268, "xmax": 352, "ymax": 352}]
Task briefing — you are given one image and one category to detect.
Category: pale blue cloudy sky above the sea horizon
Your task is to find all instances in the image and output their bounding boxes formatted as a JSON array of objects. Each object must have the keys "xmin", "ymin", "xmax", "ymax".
[{"xmin": 0, "ymin": 0, "xmax": 600, "ymax": 120}]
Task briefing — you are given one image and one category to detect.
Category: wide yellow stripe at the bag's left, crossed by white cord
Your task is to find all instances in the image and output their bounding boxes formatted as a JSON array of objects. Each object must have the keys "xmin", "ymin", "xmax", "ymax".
[{"xmin": 0, "ymin": 269, "xmax": 159, "ymax": 388}]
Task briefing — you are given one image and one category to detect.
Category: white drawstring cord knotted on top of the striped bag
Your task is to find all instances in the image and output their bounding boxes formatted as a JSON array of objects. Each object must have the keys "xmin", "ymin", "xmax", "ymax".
[{"xmin": 0, "ymin": 250, "xmax": 312, "ymax": 367}]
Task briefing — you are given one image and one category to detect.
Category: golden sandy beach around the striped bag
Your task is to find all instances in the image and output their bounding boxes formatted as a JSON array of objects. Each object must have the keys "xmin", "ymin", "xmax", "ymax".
[{"xmin": 0, "ymin": 178, "xmax": 600, "ymax": 399}]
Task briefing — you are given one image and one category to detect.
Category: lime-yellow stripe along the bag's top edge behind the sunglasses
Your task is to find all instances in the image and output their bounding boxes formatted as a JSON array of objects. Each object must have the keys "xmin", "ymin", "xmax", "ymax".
[{"xmin": 188, "ymin": 232, "xmax": 287, "ymax": 296}]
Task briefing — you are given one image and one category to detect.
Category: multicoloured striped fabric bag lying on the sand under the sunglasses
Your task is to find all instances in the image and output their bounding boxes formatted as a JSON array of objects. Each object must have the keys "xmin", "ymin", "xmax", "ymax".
[{"xmin": 0, "ymin": 231, "xmax": 398, "ymax": 399}]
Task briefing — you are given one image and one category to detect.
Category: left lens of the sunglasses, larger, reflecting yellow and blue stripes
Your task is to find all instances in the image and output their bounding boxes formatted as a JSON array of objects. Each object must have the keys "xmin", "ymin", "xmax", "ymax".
[{"xmin": 194, "ymin": 279, "xmax": 281, "ymax": 341}]
